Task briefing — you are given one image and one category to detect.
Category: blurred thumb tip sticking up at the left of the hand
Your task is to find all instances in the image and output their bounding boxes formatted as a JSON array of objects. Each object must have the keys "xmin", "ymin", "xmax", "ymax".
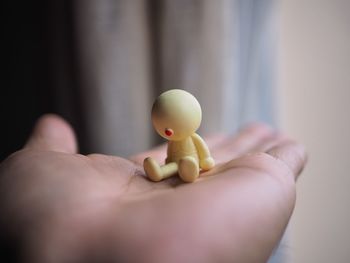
[{"xmin": 24, "ymin": 114, "xmax": 77, "ymax": 153}]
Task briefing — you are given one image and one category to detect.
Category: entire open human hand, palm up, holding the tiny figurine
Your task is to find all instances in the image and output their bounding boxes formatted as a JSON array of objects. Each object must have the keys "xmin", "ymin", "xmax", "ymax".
[{"xmin": 0, "ymin": 115, "xmax": 306, "ymax": 262}]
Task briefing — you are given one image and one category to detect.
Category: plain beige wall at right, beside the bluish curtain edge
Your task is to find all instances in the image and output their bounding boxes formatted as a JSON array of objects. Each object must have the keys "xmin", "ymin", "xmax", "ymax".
[{"xmin": 280, "ymin": 0, "xmax": 350, "ymax": 263}]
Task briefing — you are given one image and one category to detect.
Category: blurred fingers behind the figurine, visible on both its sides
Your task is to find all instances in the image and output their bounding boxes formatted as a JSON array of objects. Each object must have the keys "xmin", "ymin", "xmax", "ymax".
[{"xmin": 131, "ymin": 123, "xmax": 306, "ymax": 182}]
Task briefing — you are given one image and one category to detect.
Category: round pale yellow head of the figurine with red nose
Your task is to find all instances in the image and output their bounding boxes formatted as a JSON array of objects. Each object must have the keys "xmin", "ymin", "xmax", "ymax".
[{"xmin": 152, "ymin": 89, "xmax": 202, "ymax": 141}]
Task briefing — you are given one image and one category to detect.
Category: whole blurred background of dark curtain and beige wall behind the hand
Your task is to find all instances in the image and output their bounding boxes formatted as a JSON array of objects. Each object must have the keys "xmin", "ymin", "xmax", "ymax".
[{"xmin": 0, "ymin": 0, "xmax": 350, "ymax": 263}]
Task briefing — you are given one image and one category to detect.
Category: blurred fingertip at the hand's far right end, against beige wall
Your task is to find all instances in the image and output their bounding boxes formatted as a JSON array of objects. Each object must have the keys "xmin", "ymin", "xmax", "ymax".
[{"xmin": 267, "ymin": 140, "xmax": 307, "ymax": 178}]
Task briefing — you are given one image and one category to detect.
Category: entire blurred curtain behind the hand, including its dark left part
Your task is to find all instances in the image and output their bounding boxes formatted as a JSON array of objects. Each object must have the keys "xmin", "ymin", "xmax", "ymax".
[{"xmin": 2, "ymin": 0, "xmax": 288, "ymax": 262}]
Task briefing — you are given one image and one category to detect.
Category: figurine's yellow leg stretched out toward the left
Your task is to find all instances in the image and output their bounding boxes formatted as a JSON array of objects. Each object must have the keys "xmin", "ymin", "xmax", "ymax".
[{"xmin": 143, "ymin": 157, "xmax": 178, "ymax": 182}]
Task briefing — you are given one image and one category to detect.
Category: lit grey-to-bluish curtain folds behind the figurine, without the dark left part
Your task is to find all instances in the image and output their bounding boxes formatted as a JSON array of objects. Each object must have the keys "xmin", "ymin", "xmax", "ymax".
[{"xmin": 69, "ymin": 0, "xmax": 276, "ymax": 156}]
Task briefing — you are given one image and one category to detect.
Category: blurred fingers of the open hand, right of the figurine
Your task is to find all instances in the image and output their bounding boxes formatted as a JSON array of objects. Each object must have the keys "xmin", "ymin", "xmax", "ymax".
[{"xmin": 203, "ymin": 127, "xmax": 307, "ymax": 183}]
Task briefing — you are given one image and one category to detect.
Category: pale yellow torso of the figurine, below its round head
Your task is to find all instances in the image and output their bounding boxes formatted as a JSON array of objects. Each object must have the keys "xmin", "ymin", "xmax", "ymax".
[{"xmin": 166, "ymin": 136, "xmax": 199, "ymax": 163}]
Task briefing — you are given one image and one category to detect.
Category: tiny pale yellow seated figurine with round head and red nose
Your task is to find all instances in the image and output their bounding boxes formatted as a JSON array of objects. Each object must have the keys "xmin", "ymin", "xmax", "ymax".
[{"xmin": 143, "ymin": 89, "xmax": 215, "ymax": 182}]
